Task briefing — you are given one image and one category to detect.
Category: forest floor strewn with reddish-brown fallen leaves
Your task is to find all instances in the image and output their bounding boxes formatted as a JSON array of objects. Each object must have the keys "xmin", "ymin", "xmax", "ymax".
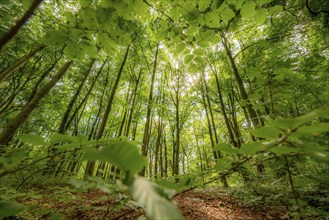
[{"xmin": 14, "ymin": 186, "xmax": 289, "ymax": 220}]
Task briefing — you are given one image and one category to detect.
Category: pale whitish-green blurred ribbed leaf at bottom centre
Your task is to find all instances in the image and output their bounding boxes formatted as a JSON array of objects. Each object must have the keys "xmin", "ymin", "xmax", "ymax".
[{"xmin": 130, "ymin": 177, "xmax": 184, "ymax": 220}]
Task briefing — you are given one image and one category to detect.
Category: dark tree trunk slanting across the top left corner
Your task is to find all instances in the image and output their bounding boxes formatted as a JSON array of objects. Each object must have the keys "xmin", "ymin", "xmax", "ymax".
[{"xmin": 0, "ymin": 0, "xmax": 42, "ymax": 52}]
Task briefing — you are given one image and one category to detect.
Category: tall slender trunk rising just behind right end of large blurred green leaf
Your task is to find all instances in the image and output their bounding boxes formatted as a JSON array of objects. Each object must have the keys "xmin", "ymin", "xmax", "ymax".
[{"xmin": 140, "ymin": 43, "xmax": 159, "ymax": 176}]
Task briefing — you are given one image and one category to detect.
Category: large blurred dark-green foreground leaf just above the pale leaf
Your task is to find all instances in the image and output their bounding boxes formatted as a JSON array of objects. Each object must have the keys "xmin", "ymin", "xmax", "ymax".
[{"xmin": 84, "ymin": 141, "xmax": 146, "ymax": 176}]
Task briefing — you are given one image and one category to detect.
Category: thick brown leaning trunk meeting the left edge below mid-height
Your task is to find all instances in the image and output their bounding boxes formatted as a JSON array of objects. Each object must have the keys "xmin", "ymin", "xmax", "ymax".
[{"xmin": 0, "ymin": 61, "xmax": 72, "ymax": 146}]
